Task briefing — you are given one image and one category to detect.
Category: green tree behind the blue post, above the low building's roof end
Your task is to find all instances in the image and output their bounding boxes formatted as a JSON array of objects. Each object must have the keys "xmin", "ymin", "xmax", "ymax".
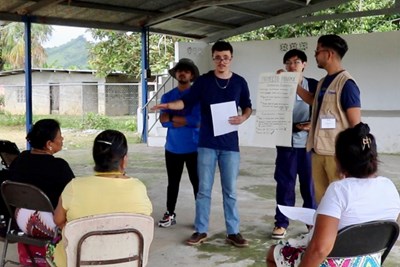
[{"xmin": 89, "ymin": 29, "xmax": 185, "ymax": 78}]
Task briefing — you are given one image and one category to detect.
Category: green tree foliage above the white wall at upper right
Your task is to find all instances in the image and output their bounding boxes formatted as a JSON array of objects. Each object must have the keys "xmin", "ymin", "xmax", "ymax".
[{"xmin": 229, "ymin": 0, "xmax": 400, "ymax": 41}]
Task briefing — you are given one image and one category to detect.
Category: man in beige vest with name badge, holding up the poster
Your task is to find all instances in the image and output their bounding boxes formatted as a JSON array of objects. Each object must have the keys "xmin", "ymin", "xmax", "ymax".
[{"xmin": 297, "ymin": 34, "xmax": 361, "ymax": 203}]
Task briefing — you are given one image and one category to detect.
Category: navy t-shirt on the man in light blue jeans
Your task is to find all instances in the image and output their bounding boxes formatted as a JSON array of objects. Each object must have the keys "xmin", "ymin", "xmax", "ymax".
[{"xmin": 182, "ymin": 71, "xmax": 251, "ymax": 151}]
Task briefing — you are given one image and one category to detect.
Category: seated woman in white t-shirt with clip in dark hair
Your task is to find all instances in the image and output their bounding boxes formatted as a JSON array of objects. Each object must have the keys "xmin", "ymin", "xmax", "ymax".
[{"xmin": 266, "ymin": 122, "xmax": 400, "ymax": 267}]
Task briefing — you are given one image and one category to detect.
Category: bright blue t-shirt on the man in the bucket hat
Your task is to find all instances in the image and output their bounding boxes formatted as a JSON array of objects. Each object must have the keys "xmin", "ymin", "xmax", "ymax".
[{"xmin": 161, "ymin": 88, "xmax": 200, "ymax": 154}]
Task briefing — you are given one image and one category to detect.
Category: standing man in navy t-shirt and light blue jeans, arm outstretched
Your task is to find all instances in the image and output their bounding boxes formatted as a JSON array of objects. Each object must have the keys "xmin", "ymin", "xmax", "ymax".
[{"xmin": 153, "ymin": 41, "xmax": 252, "ymax": 247}]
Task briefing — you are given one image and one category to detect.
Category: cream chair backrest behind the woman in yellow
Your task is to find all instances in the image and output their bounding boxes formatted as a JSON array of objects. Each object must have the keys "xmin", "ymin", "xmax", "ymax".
[{"xmin": 62, "ymin": 213, "xmax": 154, "ymax": 267}]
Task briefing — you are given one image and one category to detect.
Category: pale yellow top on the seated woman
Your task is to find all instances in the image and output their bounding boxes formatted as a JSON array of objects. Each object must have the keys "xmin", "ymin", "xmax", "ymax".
[{"xmin": 54, "ymin": 176, "xmax": 153, "ymax": 267}]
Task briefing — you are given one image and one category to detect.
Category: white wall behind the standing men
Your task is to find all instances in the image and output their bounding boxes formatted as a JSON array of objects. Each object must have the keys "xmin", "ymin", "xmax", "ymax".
[{"xmin": 175, "ymin": 31, "xmax": 400, "ymax": 153}]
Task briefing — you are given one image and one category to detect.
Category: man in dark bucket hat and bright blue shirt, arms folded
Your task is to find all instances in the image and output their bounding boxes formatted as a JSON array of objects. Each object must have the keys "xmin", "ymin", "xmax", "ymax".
[{"xmin": 158, "ymin": 58, "xmax": 200, "ymax": 227}]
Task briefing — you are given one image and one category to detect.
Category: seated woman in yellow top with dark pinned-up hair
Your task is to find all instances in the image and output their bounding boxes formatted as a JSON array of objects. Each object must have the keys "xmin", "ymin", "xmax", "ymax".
[{"xmin": 54, "ymin": 130, "xmax": 152, "ymax": 267}]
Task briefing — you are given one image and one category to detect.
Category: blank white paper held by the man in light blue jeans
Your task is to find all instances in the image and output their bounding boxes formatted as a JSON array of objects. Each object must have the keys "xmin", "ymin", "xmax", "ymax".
[{"xmin": 210, "ymin": 101, "xmax": 239, "ymax": 136}]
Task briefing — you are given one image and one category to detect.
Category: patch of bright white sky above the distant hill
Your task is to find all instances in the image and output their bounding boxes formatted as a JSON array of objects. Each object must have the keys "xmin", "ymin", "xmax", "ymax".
[{"xmin": 43, "ymin": 25, "xmax": 90, "ymax": 48}]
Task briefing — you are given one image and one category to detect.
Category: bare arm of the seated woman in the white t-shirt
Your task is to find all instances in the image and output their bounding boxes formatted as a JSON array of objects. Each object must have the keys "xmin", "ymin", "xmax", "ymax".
[{"xmin": 299, "ymin": 214, "xmax": 339, "ymax": 267}]
